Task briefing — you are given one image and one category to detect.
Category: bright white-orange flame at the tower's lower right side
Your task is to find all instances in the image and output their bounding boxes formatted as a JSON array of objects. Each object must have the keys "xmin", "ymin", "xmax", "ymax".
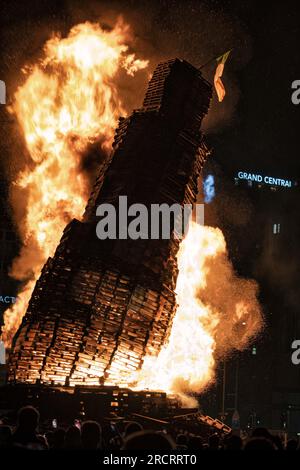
[{"xmin": 131, "ymin": 222, "xmax": 262, "ymax": 405}]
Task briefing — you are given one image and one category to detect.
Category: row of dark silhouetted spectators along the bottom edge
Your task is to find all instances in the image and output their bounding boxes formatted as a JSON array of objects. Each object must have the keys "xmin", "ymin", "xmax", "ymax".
[{"xmin": 0, "ymin": 406, "xmax": 300, "ymax": 453}]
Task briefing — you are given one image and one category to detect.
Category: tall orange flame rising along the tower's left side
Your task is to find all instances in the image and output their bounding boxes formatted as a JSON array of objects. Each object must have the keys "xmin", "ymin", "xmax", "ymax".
[{"xmin": 3, "ymin": 19, "xmax": 148, "ymax": 345}]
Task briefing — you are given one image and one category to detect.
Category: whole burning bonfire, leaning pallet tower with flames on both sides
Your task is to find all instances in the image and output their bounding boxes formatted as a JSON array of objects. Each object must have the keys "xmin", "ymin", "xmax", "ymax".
[{"xmin": 4, "ymin": 22, "xmax": 261, "ymax": 395}]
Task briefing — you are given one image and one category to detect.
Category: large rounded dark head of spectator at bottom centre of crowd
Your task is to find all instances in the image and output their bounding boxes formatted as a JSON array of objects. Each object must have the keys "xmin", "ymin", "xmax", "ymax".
[{"xmin": 123, "ymin": 431, "xmax": 176, "ymax": 451}]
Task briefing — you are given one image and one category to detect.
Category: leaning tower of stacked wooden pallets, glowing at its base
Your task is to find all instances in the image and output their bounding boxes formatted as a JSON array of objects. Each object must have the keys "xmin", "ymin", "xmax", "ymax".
[{"xmin": 9, "ymin": 59, "xmax": 211, "ymax": 386}]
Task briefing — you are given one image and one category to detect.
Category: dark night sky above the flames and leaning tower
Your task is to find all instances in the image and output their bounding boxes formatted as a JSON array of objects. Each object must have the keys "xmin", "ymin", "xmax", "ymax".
[{"xmin": 0, "ymin": 0, "xmax": 300, "ymax": 179}]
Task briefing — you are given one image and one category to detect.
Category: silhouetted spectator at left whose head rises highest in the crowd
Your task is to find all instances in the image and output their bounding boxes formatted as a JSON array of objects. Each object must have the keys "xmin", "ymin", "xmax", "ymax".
[{"xmin": 12, "ymin": 406, "xmax": 48, "ymax": 450}]
